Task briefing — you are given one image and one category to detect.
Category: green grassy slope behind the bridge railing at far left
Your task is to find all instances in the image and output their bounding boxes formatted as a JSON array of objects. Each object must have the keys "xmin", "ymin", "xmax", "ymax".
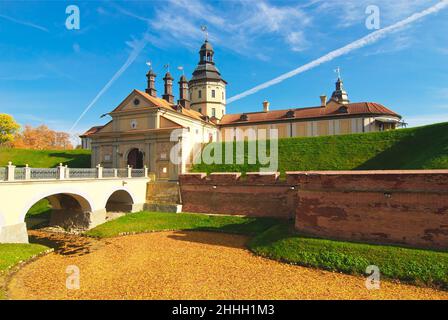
[{"xmin": 0, "ymin": 148, "xmax": 90, "ymax": 168}]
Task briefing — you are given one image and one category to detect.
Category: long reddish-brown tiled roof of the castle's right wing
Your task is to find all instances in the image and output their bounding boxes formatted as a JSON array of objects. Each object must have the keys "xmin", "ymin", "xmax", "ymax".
[{"xmin": 219, "ymin": 102, "xmax": 401, "ymax": 125}]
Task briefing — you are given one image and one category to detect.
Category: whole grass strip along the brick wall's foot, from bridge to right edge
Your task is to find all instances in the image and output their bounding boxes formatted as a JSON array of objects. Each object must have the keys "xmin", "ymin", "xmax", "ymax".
[{"xmin": 87, "ymin": 212, "xmax": 448, "ymax": 290}]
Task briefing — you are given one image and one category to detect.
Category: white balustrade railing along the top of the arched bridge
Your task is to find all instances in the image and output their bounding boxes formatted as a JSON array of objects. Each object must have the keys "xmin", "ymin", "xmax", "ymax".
[{"xmin": 0, "ymin": 162, "xmax": 152, "ymax": 182}]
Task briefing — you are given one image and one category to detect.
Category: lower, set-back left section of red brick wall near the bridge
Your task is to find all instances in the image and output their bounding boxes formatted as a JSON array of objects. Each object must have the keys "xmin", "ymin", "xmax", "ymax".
[{"xmin": 179, "ymin": 173, "xmax": 297, "ymax": 219}]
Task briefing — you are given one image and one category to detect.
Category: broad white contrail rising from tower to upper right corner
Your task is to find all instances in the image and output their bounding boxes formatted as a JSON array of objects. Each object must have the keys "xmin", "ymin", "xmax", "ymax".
[{"xmin": 227, "ymin": 0, "xmax": 448, "ymax": 104}]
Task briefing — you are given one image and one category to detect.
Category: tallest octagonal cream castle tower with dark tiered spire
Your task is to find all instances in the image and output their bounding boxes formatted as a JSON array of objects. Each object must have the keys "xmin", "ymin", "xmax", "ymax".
[{"xmin": 188, "ymin": 40, "xmax": 227, "ymax": 119}]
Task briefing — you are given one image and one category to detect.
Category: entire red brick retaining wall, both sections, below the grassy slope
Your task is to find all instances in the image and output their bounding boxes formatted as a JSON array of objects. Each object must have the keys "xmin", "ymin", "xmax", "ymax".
[{"xmin": 180, "ymin": 170, "xmax": 448, "ymax": 248}]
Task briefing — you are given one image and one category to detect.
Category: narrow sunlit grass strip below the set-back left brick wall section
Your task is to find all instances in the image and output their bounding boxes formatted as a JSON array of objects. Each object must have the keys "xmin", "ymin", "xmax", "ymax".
[{"xmin": 86, "ymin": 212, "xmax": 278, "ymax": 238}]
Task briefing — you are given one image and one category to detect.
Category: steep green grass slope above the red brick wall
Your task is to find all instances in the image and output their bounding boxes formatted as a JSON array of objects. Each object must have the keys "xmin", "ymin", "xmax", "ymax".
[{"xmin": 192, "ymin": 123, "xmax": 448, "ymax": 173}]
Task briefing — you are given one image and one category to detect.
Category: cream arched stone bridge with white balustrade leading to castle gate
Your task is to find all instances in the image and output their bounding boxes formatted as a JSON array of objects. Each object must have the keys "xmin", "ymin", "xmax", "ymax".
[{"xmin": 0, "ymin": 163, "xmax": 150, "ymax": 243}]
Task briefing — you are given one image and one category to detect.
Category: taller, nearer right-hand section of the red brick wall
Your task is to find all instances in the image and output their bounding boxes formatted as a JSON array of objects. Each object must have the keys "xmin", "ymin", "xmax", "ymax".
[{"xmin": 288, "ymin": 170, "xmax": 448, "ymax": 248}]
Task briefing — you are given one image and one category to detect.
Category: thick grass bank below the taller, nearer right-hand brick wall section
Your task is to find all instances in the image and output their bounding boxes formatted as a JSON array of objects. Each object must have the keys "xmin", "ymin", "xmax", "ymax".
[{"xmin": 248, "ymin": 223, "xmax": 448, "ymax": 290}]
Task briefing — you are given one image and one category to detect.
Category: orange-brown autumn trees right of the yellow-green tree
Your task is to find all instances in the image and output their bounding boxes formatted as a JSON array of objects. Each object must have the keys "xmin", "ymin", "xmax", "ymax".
[{"xmin": 14, "ymin": 125, "xmax": 73, "ymax": 150}]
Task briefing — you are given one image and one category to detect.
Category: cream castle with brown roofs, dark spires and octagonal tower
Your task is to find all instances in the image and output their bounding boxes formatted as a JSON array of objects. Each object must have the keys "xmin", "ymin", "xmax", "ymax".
[{"xmin": 81, "ymin": 40, "xmax": 401, "ymax": 180}]
